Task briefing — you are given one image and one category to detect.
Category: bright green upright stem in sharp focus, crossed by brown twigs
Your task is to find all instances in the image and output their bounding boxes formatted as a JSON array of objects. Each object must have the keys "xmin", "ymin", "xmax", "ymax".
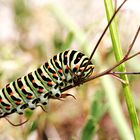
[{"xmin": 104, "ymin": 0, "xmax": 140, "ymax": 140}]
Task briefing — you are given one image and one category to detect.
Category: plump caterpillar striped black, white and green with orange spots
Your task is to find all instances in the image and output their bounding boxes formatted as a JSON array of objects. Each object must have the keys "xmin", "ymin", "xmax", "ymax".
[{"xmin": 0, "ymin": 50, "xmax": 94, "ymax": 118}]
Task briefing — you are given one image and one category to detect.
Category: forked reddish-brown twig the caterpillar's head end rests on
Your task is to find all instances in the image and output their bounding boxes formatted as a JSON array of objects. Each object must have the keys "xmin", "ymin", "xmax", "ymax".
[{"xmin": 61, "ymin": 26, "xmax": 140, "ymax": 92}]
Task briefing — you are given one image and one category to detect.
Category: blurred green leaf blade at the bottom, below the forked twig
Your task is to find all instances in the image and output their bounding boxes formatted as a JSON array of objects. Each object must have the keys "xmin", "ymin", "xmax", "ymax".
[{"xmin": 81, "ymin": 90, "xmax": 107, "ymax": 140}]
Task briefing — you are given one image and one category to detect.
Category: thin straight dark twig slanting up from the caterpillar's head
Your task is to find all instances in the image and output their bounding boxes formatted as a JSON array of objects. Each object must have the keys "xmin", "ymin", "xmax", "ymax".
[{"xmin": 81, "ymin": 0, "xmax": 127, "ymax": 75}]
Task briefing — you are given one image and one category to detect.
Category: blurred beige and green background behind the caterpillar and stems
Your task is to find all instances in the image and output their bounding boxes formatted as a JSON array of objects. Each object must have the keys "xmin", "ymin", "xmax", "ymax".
[{"xmin": 0, "ymin": 0, "xmax": 140, "ymax": 140}]
